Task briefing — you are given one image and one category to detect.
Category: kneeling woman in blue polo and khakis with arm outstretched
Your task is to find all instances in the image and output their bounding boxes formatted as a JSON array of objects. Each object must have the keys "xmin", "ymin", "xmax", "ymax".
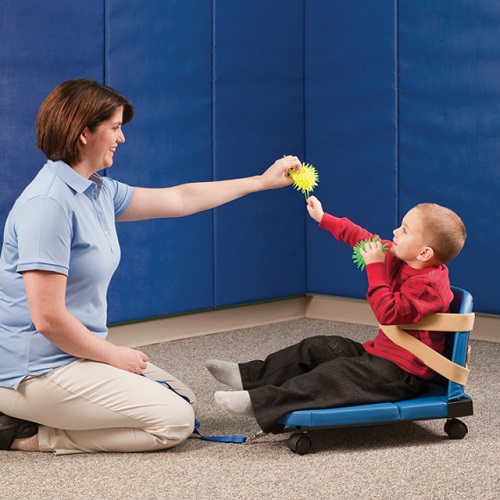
[{"xmin": 0, "ymin": 79, "xmax": 301, "ymax": 454}]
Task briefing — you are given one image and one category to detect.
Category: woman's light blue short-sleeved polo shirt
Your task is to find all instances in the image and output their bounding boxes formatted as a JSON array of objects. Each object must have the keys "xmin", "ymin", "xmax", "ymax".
[{"xmin": 0, "ymin": 161, "xmax": 134, "ymax": 388}]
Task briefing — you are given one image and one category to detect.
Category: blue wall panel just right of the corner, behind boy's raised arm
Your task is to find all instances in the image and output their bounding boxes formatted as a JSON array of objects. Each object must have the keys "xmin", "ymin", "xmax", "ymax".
[{"xmin": 305, "ymin": 0, "xmax": 397, "ymax": 297}]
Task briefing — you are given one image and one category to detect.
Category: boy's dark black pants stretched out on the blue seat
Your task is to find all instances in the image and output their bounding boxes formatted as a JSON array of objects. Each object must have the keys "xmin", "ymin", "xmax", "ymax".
[{"xmin": 239, "ymin": 336, "xmax": 426, "ymax": 432}]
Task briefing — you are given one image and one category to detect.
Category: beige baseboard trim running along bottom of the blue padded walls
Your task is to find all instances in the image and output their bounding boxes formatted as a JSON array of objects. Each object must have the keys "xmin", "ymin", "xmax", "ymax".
[{"xmin": 108, "ymin": 295, "xmax": 500, "ymax": 347}]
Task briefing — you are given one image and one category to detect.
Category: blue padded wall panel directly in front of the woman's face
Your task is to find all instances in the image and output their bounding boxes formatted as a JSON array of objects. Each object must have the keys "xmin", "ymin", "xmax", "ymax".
[{"xmin": 106, "ymin": 0, "xmax": 214, "ymax": 322}]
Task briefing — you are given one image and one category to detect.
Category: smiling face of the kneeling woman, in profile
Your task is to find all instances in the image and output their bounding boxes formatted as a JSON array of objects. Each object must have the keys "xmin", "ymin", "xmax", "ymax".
[{"xmin": 82, "ymin": 108, "xmax": 125, "ymax": 172}]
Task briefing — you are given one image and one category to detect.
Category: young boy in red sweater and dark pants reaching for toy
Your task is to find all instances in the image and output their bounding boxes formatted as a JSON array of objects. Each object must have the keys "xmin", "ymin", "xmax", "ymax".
[{"xmin": 206, "ymin": 196, "xmax": 466, "ymax": 432}]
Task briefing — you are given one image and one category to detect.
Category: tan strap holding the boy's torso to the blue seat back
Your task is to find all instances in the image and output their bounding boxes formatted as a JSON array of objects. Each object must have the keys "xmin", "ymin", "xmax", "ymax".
[{"xmin": 380, "ymin": 313, "xmax": 475, "ymax": 385}]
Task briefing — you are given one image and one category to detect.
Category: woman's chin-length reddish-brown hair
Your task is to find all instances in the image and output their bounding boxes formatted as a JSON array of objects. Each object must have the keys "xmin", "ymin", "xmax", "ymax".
[{"xmin": 36, "ymin": 78, "xmax": 134, "ymax": 166}]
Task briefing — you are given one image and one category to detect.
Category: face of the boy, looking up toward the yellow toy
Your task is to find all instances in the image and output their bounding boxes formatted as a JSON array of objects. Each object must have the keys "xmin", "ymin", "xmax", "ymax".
[{"xmin": 391, "ymin": 208, "xmax": 425, "ymax": 267}]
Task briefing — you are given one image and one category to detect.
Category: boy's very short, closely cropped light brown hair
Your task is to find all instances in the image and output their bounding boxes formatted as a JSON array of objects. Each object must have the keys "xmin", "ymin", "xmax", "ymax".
[{"xmin": 415, "ymin": 203, "xmax": 467, "ymax": 264}]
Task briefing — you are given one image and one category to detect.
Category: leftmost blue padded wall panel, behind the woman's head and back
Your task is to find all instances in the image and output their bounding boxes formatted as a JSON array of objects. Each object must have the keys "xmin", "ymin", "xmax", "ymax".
[{"xmin": 0, "ymin": 0, "xmax": 104, "ymax": 238}]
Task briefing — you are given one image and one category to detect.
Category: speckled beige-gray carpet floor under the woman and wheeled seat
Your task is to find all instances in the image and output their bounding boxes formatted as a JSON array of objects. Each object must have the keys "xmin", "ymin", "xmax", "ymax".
[{"xmin": 0, "ymin": 319, "xmax": 500, "ymax": 500}]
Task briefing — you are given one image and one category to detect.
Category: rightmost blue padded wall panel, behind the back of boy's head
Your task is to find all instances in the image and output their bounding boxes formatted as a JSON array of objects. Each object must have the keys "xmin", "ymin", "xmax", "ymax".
[{"xmin": 398, "ymin": 0, "xmax": 500, "ymax": 313}]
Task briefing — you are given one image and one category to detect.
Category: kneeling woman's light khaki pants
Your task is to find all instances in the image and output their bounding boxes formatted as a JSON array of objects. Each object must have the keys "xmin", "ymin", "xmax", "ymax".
[{"xmin": 0, "ymin": 360, "xmax": 196, "ymax": 454}]
